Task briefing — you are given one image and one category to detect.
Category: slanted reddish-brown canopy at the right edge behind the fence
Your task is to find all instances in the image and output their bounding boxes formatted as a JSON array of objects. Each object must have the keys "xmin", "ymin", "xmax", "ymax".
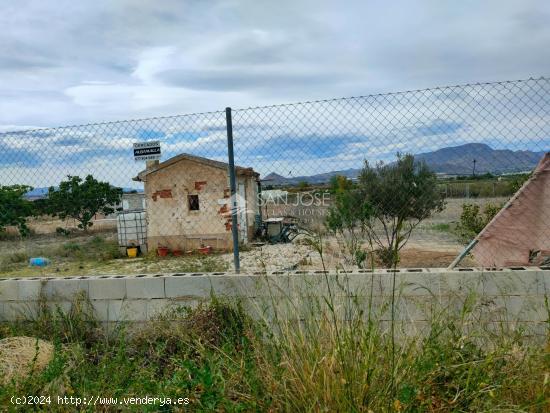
[{"xmin": 456, "ymin": 152, "xmax": 550, "ymax": 267}]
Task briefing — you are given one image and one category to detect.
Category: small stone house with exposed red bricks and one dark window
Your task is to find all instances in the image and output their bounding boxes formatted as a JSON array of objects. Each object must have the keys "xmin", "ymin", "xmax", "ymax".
[{"xmin": 133, "ymin": 153, "xmax": 260, "ymax": 251}]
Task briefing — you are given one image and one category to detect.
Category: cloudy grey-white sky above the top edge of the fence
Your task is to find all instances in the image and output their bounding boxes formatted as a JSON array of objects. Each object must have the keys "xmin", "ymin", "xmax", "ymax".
[{"xmin": 0, "ymin": 0, "xmax": 550, "ymax": 126}]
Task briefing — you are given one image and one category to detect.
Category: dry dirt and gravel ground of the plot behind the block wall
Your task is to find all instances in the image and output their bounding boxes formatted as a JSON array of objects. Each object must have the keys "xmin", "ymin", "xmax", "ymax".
[{"xmin": 0, "ymin": 198, "xmax": 505, "ymax": 276}]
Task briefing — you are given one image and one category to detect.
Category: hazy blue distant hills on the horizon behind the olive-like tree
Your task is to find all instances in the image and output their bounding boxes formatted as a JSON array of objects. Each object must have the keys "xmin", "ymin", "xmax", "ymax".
[{"xmin": 262, "ymin": 143, "xmax": 545, "ymax": 186}]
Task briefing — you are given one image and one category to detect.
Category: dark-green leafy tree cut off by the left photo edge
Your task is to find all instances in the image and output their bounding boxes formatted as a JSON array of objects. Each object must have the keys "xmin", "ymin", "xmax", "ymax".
[{"xmin": 0, "ymin": 185, "xmax": 33, "ymax": 236}]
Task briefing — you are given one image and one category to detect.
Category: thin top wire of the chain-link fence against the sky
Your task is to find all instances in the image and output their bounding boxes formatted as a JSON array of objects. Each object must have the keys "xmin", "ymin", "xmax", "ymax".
[{"xmin": 0, "ymin": 76, "xmax": 550, "ymax": 137}]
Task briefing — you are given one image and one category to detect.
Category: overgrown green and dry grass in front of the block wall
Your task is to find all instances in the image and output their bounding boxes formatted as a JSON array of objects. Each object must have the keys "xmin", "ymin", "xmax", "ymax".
[{"xmin": 0, "ymin": 292, "xmax": 550, "ymax": 412}]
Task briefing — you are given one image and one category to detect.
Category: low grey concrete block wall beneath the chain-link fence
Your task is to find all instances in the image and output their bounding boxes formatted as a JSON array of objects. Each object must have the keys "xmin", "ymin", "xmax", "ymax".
[{"xmin": 0, "ymin": 267, "xmax": 550, "ymax": 328}]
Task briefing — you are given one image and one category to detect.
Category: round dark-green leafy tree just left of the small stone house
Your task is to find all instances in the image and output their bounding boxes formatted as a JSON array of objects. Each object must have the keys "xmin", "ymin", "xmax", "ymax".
[{"xmin": 47, "ymin": 175, "xmax": 122, "ymax": 231}]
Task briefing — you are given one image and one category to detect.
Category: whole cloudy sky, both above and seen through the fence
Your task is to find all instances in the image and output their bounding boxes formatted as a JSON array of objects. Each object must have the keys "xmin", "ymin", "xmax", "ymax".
[{"xmin": 0, "ymin": 0, "xmax": 550, "ymax": 186}]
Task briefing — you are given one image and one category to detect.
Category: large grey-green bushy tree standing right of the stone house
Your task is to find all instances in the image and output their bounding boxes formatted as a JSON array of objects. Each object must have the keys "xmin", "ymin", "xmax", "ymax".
[{"xmin": 327, "ymin": 154, "xmax": 445, "ymax": 267}]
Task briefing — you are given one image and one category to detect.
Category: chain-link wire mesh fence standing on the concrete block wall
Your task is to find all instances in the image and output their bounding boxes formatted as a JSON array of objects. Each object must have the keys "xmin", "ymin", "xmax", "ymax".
[{"xmin": 0, "ymin": 78, "xmax": 550, "ymax": 275}]
